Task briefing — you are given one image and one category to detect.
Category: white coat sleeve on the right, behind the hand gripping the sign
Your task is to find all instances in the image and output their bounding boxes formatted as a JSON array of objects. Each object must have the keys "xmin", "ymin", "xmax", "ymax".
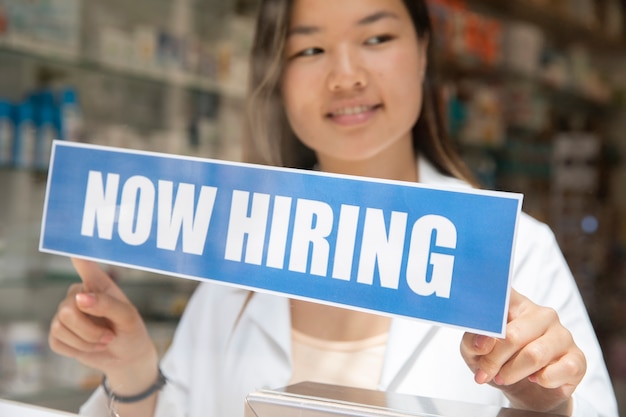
[{"xmin": 513, "ymin": 215, "xmax": 618, "ymax": 417}]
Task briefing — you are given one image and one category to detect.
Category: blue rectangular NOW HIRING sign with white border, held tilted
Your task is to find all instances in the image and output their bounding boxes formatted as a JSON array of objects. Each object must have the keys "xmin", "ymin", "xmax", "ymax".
[{"xmin": 40, "ymin": 142, "xmax": 522, "ymax": 336}]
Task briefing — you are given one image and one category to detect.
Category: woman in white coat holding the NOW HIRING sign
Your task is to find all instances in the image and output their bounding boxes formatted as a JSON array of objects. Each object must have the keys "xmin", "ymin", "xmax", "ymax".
[{"xmin": 50, "ymin": 0, "xmax": 617, "ymax": 417}]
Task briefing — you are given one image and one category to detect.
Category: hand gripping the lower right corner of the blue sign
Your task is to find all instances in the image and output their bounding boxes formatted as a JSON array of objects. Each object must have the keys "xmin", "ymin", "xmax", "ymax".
[{"xmin": 461, "ymin": 289, "xmax": 587, "ymax": 415}]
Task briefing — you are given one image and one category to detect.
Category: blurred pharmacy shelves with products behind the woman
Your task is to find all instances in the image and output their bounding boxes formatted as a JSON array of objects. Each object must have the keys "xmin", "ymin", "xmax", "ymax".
[{"xmin": 0, "ymin": 0, "xmax": 626, "ymax": 412}]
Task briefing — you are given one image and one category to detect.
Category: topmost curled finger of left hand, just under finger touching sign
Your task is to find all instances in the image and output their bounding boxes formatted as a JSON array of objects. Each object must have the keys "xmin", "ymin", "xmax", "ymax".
[{"xmin": 76, "ymin": 293, "xmax": 143, "ymax": 333}]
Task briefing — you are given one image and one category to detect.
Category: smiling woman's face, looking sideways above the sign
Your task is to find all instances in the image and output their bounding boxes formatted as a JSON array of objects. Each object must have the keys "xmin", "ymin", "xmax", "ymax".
[{"xmin": 281, "ymin": 0, "xmax": 426, "ymax": 170}]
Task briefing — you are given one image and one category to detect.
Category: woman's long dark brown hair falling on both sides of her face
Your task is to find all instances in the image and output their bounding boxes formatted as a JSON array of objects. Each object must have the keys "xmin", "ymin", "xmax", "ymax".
[{"xmin": 243, "ymin": 0, "xmax": 473, "ymax": 183}]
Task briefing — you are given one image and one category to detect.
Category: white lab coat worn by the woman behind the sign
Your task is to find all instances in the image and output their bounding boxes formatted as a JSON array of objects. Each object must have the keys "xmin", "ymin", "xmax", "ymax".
[{"xmin": 81, "ymin": 158, "xmax": 617, "ymax": 417}]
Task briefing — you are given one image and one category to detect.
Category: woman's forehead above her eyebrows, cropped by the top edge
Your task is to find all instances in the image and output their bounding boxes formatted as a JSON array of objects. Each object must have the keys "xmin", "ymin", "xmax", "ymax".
[{"xmin": 290, "ymin": 0, "xmax": 410, "ymax": 28}]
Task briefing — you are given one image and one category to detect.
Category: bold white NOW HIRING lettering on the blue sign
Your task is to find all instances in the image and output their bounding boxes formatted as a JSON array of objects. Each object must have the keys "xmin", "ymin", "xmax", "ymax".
[{"xmin": 81, "ymin": 171, "xmax": 457, "ymax": 298}]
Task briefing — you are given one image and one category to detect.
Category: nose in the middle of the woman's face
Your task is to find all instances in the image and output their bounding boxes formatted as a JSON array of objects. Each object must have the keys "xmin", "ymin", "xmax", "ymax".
[{"xmin": 328, "ymin": 49, "xmax": 367, "ymax": 92}]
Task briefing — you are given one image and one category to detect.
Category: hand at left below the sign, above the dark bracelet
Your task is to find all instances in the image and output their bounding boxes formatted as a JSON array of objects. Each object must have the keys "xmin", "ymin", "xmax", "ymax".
[{"xmin": 49, "ymin": 259, "xmax": 158, "ymax": 395}]
